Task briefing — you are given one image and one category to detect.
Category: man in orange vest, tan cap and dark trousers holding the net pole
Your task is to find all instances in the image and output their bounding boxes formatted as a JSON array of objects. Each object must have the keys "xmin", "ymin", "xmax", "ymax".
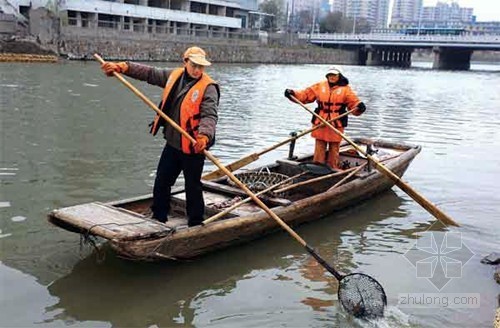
[{"xmin": 102, "ymin": 47, "xmax": 220, "ymax": 226}]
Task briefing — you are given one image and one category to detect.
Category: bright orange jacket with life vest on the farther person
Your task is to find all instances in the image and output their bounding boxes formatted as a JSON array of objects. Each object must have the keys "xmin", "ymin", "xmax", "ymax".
[{"xmin": 295, "ymin": 80, "xmax": 360, "ymax": 142}]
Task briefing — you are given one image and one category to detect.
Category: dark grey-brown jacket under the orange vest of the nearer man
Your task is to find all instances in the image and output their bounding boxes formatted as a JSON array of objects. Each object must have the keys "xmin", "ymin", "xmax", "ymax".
[{"xmin": 125, "ymin": 62, "xmax": 219, "ymax": 149}]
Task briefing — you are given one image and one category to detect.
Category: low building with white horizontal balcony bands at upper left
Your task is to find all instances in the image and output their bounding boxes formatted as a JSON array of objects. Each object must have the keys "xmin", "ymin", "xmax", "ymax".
[{"xmin": 2, "ymin": 0, "xmax": 258, "ymax": 36}]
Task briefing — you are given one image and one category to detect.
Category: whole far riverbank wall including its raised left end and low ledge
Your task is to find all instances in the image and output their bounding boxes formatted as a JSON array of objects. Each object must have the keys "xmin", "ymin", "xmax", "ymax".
[{"xmin": 0, "ymin": 8, "xmax": 358, "ymax": 65}]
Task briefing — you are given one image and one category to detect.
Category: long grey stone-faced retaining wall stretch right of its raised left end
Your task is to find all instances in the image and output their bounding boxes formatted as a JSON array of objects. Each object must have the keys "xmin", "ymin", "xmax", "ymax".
[{"xmin": 59, "ymin": 37, "xmax": 358, "ymax": 64}]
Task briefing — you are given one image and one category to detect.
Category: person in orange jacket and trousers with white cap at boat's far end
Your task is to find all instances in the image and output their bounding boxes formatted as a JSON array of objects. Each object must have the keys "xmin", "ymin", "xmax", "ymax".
[{"xmin": 285, "ymin": 66, "xmax": 366, "ymax": 169}]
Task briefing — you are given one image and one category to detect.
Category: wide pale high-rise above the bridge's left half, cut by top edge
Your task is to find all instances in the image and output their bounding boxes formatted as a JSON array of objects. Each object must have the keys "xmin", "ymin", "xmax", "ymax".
[{"xmin": 332, "ymin": 0, "xmax": 389, "ymax": 28}]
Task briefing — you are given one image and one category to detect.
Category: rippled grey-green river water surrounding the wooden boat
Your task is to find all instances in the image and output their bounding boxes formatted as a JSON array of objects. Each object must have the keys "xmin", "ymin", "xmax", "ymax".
[{"xmin": 0, "ymin": 62, "xmax": 500, "ymax": 327}]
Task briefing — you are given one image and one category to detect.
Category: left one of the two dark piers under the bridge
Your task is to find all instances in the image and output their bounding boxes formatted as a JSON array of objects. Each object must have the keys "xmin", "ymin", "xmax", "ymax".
[{"xmin": 365, "ymin": 47, "xmax": 413, "ymax": 67}]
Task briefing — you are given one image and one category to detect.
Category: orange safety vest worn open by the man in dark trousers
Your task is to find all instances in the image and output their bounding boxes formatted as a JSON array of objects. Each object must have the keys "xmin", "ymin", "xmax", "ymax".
[{"xmin": 151, "ymin": 67, "xmax": 217, "ymax": 154}]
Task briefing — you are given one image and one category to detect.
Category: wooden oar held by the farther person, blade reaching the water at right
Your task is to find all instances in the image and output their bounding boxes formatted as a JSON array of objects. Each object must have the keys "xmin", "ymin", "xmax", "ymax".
[{"xmin": 291, "ymin": 96, "xmax": 460, "ymax": 227}]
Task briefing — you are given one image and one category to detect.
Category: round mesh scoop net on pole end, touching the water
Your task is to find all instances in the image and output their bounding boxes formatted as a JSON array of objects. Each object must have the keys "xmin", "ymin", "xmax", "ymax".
[{"xmin": 338, "ymin": 273, "xmax": 387, "ymax": 319}]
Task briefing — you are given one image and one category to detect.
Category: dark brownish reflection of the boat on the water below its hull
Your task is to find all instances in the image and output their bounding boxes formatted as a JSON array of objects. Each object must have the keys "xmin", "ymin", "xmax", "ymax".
[{"xmin": 46, "ymin": 192, "xmax": 401, "ymax": 326}]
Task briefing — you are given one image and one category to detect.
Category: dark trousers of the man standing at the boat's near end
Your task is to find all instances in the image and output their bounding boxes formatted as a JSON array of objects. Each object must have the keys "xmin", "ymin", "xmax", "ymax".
[{"xmin": 152, "ymin": 145, "xmax": 205, "ymax": 226}]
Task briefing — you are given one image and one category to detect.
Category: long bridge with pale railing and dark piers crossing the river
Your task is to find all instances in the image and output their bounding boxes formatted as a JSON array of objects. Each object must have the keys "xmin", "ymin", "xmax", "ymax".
[{"xmin": 299, "ymin": 33, "xmax": 500, "ymax": 70}]
